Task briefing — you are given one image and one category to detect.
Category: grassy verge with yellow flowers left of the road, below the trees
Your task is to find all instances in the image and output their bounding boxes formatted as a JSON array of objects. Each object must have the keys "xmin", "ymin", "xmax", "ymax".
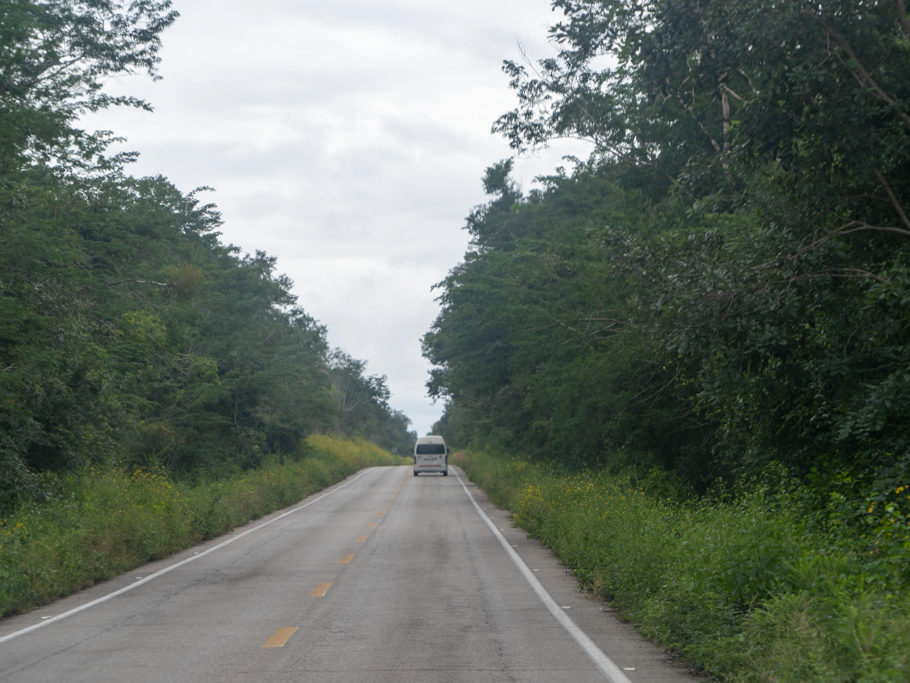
[{"xmin": 0, "ymin": 435, "xmax": 407, "ymax": 616}]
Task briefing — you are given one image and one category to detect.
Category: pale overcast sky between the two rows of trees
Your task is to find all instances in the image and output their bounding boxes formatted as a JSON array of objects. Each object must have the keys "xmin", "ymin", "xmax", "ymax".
[{"xmin": 87, "ymin": 0, "xmax": 578, "ymax": 434}]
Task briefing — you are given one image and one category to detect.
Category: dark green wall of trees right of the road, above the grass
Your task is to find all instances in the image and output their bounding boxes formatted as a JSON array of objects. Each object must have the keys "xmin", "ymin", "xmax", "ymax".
[{"xmin": 424, "ymin": 0, "xmax": 910, "ymax": 496}]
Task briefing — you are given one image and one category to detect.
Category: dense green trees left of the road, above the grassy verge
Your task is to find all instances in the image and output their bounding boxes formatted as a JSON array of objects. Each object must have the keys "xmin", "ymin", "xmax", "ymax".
[{"xmin": 0, "ymin": 0, "xmax": 412, "ymax": 512}]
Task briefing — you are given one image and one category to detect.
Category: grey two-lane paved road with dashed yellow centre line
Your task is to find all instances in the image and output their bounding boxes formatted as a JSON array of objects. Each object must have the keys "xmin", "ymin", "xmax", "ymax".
[{"xmin": 0, "ymin": 467, "xmax": 693, "ymax": 683}]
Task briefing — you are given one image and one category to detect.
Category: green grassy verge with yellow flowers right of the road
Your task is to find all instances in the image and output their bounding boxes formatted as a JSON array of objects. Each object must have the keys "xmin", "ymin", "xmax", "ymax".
[{"xmin": 458, "ymin": 453, "xmax": 910, "ymax": 682}]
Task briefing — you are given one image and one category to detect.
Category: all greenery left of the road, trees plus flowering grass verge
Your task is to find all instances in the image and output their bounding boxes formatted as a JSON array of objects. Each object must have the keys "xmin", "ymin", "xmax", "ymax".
[{"xmin": 0, "ymin": 0, "xmax": 415, "ymax": 616}]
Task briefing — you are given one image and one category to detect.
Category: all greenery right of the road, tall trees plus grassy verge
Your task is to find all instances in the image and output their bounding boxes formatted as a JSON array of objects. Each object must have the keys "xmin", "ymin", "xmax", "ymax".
[{"xmin": 423, "ymin": 0, "xmax": 910, "ymax": 681}]
